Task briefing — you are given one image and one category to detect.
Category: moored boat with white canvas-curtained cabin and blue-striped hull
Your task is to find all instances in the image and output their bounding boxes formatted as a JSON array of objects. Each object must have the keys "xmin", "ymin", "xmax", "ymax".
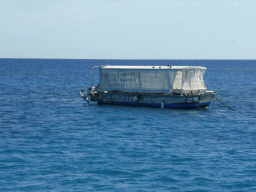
[{"xmin": 80, "ymin": 65, "xmax": 216, "ymax": 109}]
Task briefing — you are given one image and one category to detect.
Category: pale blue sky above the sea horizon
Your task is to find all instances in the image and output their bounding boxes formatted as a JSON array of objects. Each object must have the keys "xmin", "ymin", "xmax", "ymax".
[{"xmin": 0, "ymin": 0, "xmax": 256, "ymax": 59}]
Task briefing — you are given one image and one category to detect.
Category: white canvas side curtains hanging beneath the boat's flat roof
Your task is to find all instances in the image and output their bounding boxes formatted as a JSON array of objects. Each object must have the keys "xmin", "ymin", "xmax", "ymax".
[{"xmin": 98, "ymin": 67, "xmax": 206, "ymax": 93}]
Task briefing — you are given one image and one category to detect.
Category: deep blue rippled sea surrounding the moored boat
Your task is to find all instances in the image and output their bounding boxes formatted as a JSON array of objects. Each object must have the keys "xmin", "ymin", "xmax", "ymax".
[{"xmin": 0, "ymin": 59, "xmax": 256, "ymax": 191}]
